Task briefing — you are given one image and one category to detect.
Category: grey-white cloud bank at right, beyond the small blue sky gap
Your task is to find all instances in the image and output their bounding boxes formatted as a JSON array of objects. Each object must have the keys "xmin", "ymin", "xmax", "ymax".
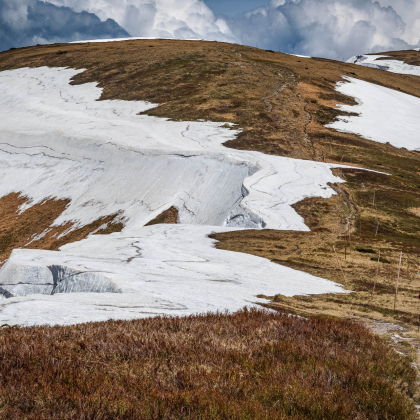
[{"xmin": 228, "ymin": 0, "xmax": 420, "ymax": 60}]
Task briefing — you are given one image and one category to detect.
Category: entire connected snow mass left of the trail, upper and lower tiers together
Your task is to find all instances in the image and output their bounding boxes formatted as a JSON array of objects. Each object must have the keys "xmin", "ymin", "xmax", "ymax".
[{"xmin": 0, "ymin": 67, "xmax": 350, "ymax": 325}]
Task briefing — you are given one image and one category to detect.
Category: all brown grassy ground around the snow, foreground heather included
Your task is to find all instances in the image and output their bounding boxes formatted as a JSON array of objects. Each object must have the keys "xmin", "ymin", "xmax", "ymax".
[{"xmin": 0, "ymin": 40, "xmax": 420, "ymax": 419}]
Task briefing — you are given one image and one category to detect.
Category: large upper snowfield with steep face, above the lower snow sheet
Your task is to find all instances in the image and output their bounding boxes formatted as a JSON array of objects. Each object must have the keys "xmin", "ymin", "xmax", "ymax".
[{"xmin": 0, "ymin": 67, "xmax": 348, "ymax": 230}]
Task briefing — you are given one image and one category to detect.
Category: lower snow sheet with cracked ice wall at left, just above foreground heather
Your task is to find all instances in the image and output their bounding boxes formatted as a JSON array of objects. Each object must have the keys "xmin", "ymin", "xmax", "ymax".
[{"xmin": 0, "ymin": 225, "xmax": 343, "ymax": 325}]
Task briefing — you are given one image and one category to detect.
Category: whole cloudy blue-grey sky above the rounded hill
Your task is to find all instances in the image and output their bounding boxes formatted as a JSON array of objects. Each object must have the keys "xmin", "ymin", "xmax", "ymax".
[{"xmin": 0, "ymin": 0, "xmax": 420, "ymax": 60}]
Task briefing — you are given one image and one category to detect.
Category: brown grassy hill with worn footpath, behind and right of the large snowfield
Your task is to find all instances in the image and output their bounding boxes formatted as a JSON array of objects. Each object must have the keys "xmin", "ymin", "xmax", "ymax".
[{"xmin": 0, "ymin": 40, "xmax": 420, "ymax": 324}]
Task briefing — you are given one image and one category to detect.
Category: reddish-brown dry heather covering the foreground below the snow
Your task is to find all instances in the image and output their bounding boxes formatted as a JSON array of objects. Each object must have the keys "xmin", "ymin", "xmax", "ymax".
[{"xmin": 0, "ymin": 310, "xmax": 416, "ymax": 420}]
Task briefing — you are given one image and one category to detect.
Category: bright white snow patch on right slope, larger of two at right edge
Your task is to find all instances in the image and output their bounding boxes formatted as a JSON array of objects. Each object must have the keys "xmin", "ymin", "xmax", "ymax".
[{"xmin": 328, "ymin": 76, "xmax": 420, "ymax": 150}]
